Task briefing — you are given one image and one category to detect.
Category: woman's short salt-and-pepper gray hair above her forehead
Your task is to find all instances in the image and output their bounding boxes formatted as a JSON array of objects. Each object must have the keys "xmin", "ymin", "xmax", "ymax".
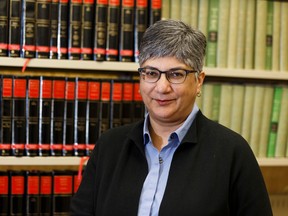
[{"xmin": 139, "ymin": 19, "xmax": 207, "ymax": 72}]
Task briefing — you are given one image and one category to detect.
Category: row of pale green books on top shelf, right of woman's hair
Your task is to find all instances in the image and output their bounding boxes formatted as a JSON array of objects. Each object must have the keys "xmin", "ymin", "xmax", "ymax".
[{"xmin": 162, "ymin": 0, "xmax": 288, "ymax": 71}]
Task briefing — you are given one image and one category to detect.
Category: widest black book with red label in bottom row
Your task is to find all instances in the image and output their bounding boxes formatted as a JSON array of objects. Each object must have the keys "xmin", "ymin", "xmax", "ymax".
[{"xmin": 52, "ymin": 170, "xmax": 73, "ymax": 215}]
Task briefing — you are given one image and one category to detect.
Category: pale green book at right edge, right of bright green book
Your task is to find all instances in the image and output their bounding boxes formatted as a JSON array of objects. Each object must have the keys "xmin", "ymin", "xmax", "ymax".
[{"xmin": 275, "ymin": 85, "xmax": 288, "ymax": 157}]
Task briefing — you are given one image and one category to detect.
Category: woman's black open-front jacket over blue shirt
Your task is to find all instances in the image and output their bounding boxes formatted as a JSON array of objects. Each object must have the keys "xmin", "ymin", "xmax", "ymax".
[{"xmin": 71, "ymin": 111, "xmax": 272, "ymax": 216}]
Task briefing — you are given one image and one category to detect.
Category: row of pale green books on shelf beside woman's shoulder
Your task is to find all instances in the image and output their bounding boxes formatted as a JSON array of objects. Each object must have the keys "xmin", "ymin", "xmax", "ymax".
[{"xmin": 197, "ymin": 82, "xmax": 288, "ymax": 158}]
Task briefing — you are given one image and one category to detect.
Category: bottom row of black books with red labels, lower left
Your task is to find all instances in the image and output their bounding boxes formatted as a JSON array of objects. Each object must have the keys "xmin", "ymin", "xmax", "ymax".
[{"xmin": 0, "ymin": 170, "xmax": 81, "ymax": 216}]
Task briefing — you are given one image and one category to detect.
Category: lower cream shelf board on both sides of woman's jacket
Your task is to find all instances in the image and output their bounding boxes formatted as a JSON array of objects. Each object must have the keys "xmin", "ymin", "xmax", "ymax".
[{"xmin": 0, "ymin": 157, "xmax": 288, "ymax": 167}]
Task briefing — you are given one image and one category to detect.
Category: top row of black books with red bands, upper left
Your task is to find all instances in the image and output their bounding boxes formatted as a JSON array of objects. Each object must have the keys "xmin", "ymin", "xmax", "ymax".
[{"xmin": 0, "ymin": 0, "xmax": 161, "ymax": 61}]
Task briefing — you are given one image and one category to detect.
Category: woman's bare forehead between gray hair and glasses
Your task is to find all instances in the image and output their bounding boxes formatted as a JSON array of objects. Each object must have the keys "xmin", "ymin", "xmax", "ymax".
[{"xmin": 141, "ymin": 56, "xmax": 187, "ymax": 70}]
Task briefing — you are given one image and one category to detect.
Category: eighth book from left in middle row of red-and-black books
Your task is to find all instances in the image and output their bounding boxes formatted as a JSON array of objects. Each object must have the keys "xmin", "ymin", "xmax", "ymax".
[{"xmin": 86, "ymin": 79, "xmax": 101, "ymax": 155}]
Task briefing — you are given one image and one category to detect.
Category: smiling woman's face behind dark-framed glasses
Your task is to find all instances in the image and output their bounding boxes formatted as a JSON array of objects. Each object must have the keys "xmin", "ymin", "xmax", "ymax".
[{"xmin": 140, "ymin": 57, "xmax": 205, "ymax": 123}]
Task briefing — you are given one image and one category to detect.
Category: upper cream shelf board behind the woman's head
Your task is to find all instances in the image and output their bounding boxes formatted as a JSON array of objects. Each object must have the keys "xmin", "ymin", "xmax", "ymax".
[{"xmin": 0, "ymin": 57, "xmax": 288, "ymax": 81}]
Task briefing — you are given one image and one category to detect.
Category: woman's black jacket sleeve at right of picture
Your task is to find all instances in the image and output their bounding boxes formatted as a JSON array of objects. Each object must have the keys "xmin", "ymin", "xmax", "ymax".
[{"xmin": 230, "ymin": 138, "xmax": 273, "ymax": 216}]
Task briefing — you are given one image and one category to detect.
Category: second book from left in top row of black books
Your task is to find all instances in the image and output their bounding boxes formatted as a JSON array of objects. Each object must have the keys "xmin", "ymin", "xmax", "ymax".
[{"xmin": 8, "ymin": 0, "xmax": 22, "ymax": 57}]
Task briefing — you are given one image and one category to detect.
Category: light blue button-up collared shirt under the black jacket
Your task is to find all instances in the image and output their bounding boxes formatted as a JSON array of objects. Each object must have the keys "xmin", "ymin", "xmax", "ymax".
[{"xmin": 138, "ymin": 104, "xmax": 199, "ymax": 216}]
